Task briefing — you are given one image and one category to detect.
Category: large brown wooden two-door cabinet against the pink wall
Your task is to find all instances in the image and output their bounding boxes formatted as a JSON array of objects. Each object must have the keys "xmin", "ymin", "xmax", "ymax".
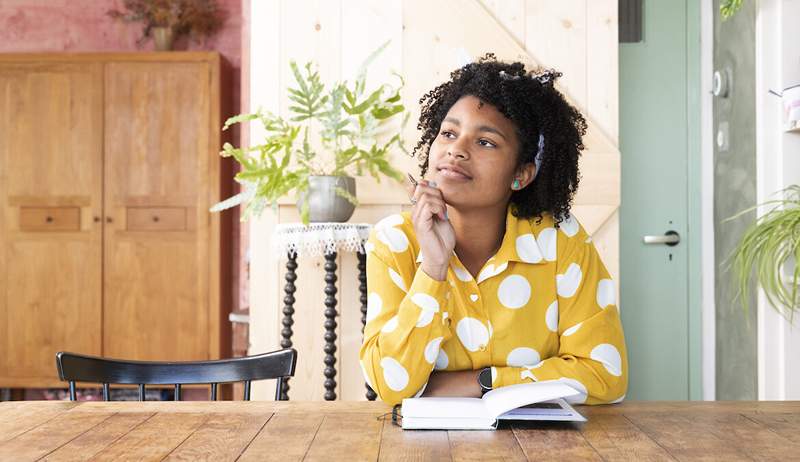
[{"xmin": 0, "ymin": 52, "xmax": 228, "ymax": 387}]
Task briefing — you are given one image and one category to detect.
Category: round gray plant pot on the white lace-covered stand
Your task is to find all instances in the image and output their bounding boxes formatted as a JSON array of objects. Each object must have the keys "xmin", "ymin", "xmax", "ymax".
[{"xmin": 297, "ymin": 176, "xmax": 356, "ymax": 223}]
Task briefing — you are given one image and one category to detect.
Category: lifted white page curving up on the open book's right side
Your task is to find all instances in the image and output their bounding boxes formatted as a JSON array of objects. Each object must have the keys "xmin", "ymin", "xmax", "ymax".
[{"xmin": 481, "ymin": 380, "xmax": 579, "ymax": 419}]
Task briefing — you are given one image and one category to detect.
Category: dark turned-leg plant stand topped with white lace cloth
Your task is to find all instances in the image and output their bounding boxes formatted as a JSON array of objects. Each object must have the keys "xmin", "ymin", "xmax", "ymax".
[{"xmin": 272, "ymin": 223, "xmax": 377, "ymax": 401}]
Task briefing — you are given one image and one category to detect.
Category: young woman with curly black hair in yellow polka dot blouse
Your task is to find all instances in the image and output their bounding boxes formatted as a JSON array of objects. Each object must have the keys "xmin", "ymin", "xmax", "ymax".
[{"xmin": 360, "ymin": 54, "xmax": 628, "ymax": 404}]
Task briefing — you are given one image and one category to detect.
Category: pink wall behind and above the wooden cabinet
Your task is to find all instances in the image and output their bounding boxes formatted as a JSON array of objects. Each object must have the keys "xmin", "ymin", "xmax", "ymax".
[{"xmin": 0, "ymin": 0, "xmax": 247, "ymax": 318}]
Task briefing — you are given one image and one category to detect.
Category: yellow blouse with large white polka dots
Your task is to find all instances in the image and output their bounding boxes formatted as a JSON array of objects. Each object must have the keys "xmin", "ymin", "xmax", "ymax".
[{"xmin": 360, "ymin": 209, "xmax": 628, "ymax": 404}]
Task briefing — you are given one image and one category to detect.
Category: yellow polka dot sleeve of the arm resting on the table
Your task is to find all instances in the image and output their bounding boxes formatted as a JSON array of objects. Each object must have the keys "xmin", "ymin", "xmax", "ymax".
[{"xmin": 492, "ymin": 233, "xmax": 628, "ymax": 404}]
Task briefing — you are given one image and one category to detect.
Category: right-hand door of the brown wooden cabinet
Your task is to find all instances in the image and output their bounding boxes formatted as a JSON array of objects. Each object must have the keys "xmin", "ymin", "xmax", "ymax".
[{"xmin": 103, "ymin": 62, "xmax": 218, "ymax": 360}]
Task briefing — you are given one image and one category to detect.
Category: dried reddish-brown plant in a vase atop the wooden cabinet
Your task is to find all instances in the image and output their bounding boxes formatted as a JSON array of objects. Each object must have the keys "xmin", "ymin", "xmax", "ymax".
[{"xmin": 107, "ymin": 0, "xmax": 225, "ymax": 51}]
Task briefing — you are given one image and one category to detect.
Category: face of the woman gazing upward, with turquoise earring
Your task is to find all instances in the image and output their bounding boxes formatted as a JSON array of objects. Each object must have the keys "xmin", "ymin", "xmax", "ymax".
[{"xmin": 427, "ymin": 95, "xmax": 533, "ymax": 208}]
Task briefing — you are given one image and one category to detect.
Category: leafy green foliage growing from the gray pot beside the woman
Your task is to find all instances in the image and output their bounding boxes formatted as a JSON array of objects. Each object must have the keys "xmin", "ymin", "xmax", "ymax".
[{"xmin": 211, "ymin": 42, "xmax": 409, "ymax": 224}]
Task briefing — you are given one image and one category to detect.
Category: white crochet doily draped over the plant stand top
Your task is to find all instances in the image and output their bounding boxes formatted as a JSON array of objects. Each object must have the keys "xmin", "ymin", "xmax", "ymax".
[{"xmin": 272, "ymin": 223, "xmax": 372, "ymax": 258}]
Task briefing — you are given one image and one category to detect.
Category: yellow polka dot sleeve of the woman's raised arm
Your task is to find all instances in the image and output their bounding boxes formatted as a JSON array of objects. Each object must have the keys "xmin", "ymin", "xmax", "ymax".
[{"xmin": 360, "ymin": 228, "xmax": 453, "ymax": 405}]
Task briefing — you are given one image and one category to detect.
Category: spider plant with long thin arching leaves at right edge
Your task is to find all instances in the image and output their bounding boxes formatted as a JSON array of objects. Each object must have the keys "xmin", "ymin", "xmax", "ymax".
[{"xmin": 723, "ymin": 185, "xmax": 800, "ymax": 321}]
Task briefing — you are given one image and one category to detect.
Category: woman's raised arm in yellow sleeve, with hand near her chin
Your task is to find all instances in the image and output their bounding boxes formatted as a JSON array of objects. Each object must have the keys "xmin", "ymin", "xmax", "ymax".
[{"xmin": 360, "ymin": 181, "xmax": 455, "ymax": 405}]
